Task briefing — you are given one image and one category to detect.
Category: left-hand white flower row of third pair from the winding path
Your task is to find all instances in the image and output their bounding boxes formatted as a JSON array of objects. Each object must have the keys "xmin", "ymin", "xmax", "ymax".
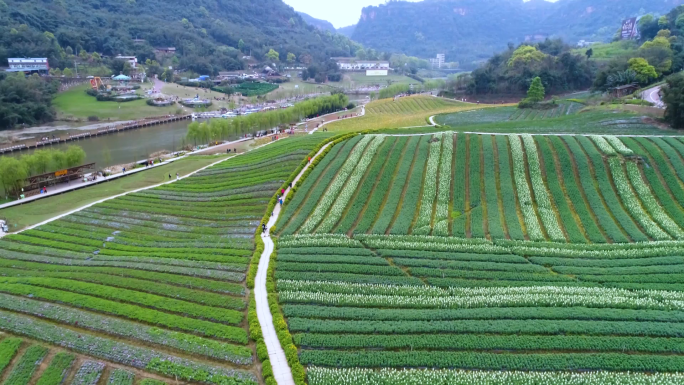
[{"xmin": 508, "ymin": 134, "xmax": 545, "ymax": 241}]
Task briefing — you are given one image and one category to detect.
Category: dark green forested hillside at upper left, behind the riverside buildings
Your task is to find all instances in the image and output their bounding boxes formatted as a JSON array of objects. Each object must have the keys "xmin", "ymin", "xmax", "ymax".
[{"xmin": 0, "ymin": 0, "xmax": 354, "ymax": 69}]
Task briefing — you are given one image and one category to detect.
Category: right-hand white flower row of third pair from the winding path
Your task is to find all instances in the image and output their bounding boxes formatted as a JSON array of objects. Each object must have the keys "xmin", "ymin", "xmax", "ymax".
[{"xmin": 522, "ymin": 135, "xmax": 566, "ymax": 242}]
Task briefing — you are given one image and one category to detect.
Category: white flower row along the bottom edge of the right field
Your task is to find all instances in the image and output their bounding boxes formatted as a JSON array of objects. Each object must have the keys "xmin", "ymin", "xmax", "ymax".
[{"xmin": 308, "ymin": 366, "xmax": 684, "ymax": 385}]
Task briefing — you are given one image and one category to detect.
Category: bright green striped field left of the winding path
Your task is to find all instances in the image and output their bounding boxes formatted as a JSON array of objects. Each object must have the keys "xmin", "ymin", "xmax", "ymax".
[{"xmin": 0, "ymin": 133, "xmax": 330, "ymax": 385}]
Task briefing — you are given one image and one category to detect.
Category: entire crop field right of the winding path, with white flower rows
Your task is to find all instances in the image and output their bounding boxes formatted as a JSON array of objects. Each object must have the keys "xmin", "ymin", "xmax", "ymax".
[{"xmin": 271, "ymin": 132, "xmax": 684, "ymax": 385}]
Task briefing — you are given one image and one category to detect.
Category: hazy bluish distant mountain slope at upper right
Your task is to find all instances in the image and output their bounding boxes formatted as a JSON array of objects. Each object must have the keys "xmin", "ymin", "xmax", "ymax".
[{"xmin": 351, "ymin": 0, "xmax": 684, "ymax": 67}]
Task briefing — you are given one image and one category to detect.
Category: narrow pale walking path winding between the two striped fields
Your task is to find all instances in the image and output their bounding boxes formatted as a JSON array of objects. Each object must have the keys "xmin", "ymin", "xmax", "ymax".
[{"xmin": 254, "ymin": 143, "xmax": 331, "ymax": 385}]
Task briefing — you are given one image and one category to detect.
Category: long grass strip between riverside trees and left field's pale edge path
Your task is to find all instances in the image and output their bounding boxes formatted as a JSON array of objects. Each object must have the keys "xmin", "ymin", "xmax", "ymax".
[{"xmin": 0, "ymin": 155, "xmax": 228, "ymax": 231}]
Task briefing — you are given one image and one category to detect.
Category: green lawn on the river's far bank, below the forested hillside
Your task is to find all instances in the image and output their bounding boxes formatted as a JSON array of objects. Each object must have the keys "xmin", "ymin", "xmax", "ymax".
[{"xmin": 53, "ymin": 85, "xmax": 178, "ymax": 121}]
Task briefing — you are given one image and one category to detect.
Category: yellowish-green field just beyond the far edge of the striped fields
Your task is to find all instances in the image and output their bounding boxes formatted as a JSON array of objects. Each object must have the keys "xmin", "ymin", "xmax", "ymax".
[{"xmin": 326, "ymin": 96, "xmax": 494, "ymax": 132}]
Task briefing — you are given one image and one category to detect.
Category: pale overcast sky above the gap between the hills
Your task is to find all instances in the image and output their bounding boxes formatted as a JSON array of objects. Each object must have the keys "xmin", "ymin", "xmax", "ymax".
[{"xmin": 283, "ymin": 0, "xmax": 557, "ymax": 28}]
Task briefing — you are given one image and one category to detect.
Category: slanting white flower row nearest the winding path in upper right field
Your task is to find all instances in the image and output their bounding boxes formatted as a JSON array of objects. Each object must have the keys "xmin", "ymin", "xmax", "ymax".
[{"xmin": 300, "ymin": 135, "xmax": 374, "ymax": 233}]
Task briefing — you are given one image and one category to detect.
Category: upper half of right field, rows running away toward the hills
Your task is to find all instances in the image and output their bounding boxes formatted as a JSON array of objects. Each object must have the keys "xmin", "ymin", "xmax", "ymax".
[{"xmin": 278, "ymin": 132, "xmax": 684, "ymax": 243}]
